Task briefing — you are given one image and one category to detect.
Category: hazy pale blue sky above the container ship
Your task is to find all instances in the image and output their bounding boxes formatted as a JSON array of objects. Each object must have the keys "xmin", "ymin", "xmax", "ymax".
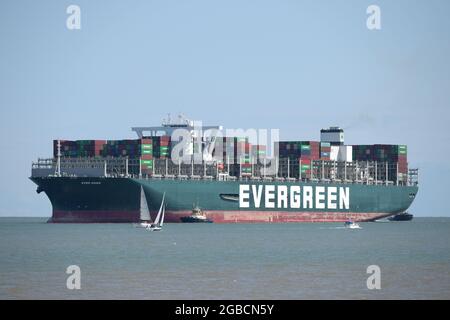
[{"xmin": 0, "ymin": 0, "xmax": 450, "ymax": 216}]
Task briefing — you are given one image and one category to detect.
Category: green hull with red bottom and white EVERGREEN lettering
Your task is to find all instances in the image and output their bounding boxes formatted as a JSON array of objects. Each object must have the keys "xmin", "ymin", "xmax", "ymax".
[{"xmin": 31, "ymin": 177, "xmax": 418, "ymax": 223}]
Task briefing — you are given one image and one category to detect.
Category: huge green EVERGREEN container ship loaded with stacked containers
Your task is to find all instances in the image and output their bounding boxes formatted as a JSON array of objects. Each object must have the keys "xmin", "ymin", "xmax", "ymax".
[{"xmin": 30, "ymin": 117, "xmax": 418, "ymax": 223}]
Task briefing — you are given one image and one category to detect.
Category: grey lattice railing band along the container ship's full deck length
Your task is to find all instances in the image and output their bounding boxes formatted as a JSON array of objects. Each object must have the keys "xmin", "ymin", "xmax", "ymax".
[{"xmin": 32, "ymin": 157, "xmax": 419, "ymax": 185}]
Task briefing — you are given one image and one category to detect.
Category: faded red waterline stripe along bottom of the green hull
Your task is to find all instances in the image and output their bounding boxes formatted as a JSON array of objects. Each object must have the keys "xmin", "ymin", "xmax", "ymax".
[{"xmin": 51, "ymin": 210, "xmax": 391, "ymax": 223}]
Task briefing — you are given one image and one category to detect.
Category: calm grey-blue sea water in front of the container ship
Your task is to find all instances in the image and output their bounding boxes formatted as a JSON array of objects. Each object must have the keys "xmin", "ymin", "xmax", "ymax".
[{"xmin": 0, "ymin": 218, "xmax": 450, "ymax": 299}]
